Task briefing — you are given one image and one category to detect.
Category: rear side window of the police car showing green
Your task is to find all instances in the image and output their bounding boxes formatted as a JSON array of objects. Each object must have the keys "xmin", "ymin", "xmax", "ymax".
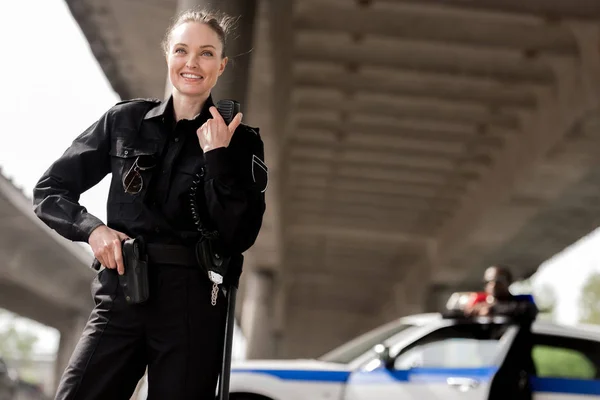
[{"xmin": 531, "ymin": 345, "xmax": 596, "ymax": 379}]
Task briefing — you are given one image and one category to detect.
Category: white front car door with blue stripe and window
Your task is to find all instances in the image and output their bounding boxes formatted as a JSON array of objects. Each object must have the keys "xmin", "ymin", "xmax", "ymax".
[{"xmin": 344, "ymin": 323, "xmax": 518, "ymax": 400}]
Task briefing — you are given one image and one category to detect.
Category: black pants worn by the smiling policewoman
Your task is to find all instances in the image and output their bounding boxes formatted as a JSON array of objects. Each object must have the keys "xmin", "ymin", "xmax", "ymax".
[{"xmin": 56, "ymin": 265, "xmax": 227, "ymax": 400}]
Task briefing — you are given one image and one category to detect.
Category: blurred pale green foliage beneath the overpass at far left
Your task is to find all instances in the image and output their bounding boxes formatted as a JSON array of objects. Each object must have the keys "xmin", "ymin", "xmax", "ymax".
[{"xmin": 0, "ymin": 310, "xmax": 38, "ymax": 362}]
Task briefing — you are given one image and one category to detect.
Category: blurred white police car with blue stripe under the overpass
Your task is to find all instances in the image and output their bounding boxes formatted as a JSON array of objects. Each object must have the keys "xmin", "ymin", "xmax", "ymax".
[{"xmin": 230, "ymin": 293, "xmax": 600, "ymax": 400}]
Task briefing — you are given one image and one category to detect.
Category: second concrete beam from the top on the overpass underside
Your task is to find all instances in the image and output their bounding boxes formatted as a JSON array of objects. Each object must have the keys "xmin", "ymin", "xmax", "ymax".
[{"xmin": 293, "ymin": 59, "xmax": 548, "ymax": 109}]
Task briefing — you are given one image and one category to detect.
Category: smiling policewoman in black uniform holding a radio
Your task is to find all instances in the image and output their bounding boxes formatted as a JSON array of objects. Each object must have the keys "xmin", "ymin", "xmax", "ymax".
[{"xmin": 34, "ymin": 11, "xmax": 267, "ymax": 400}]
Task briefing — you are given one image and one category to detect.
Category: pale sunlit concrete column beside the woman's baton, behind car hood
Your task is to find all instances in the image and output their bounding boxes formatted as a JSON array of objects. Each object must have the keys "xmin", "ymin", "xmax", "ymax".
[{"xmin": 242, "ymin": 269, "xmax": 275, "ymax": 359}]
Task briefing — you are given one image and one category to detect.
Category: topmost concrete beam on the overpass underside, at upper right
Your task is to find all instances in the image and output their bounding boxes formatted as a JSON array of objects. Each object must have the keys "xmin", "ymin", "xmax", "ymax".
[{"xmin": 294, "ymin": 0, "xmax": 577, "ymax": 54}]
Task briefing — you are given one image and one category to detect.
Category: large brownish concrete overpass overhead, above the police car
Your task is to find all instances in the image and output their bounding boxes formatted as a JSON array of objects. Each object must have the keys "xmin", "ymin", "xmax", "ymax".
[{"xmin": 2, "ymin": 0, "xmax": 600, "ymax": 384}]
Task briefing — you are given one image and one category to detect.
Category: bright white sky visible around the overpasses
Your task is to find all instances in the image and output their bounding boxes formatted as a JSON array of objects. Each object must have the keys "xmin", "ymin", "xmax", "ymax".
[{"xmin": 0, "ymin": 0, "xmax": 600, "ymax": 352}]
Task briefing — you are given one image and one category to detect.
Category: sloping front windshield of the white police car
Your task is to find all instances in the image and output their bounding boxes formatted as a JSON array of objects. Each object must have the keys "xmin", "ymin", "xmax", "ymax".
[{"xmin": 319, "ymin": 322, "xmax": 414, "ymax": 364}]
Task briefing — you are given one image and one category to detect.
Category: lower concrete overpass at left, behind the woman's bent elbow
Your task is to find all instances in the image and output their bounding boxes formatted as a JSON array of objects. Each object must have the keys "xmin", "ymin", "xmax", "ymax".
[{"xmin": 0, "ymin": 171, "xmax": 94, "ymax": 386}]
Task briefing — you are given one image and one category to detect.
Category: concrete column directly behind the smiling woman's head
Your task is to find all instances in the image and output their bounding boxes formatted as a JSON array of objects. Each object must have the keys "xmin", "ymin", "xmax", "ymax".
[{"xmin": 166, "ymin": 0, "xmax": 256, "ymax": 104}]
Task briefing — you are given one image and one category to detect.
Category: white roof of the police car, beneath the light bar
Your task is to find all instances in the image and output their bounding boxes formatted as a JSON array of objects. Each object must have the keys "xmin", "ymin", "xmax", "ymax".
[{"xmin": 394, "ymin": 313, "xmax": 600, "ymax": 341}]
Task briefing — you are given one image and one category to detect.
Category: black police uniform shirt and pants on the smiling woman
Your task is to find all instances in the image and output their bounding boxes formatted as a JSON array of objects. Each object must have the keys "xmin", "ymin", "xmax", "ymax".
[{"xmin": 34, "ymin": 98, "xmax": 267, "ymax": 400}]
